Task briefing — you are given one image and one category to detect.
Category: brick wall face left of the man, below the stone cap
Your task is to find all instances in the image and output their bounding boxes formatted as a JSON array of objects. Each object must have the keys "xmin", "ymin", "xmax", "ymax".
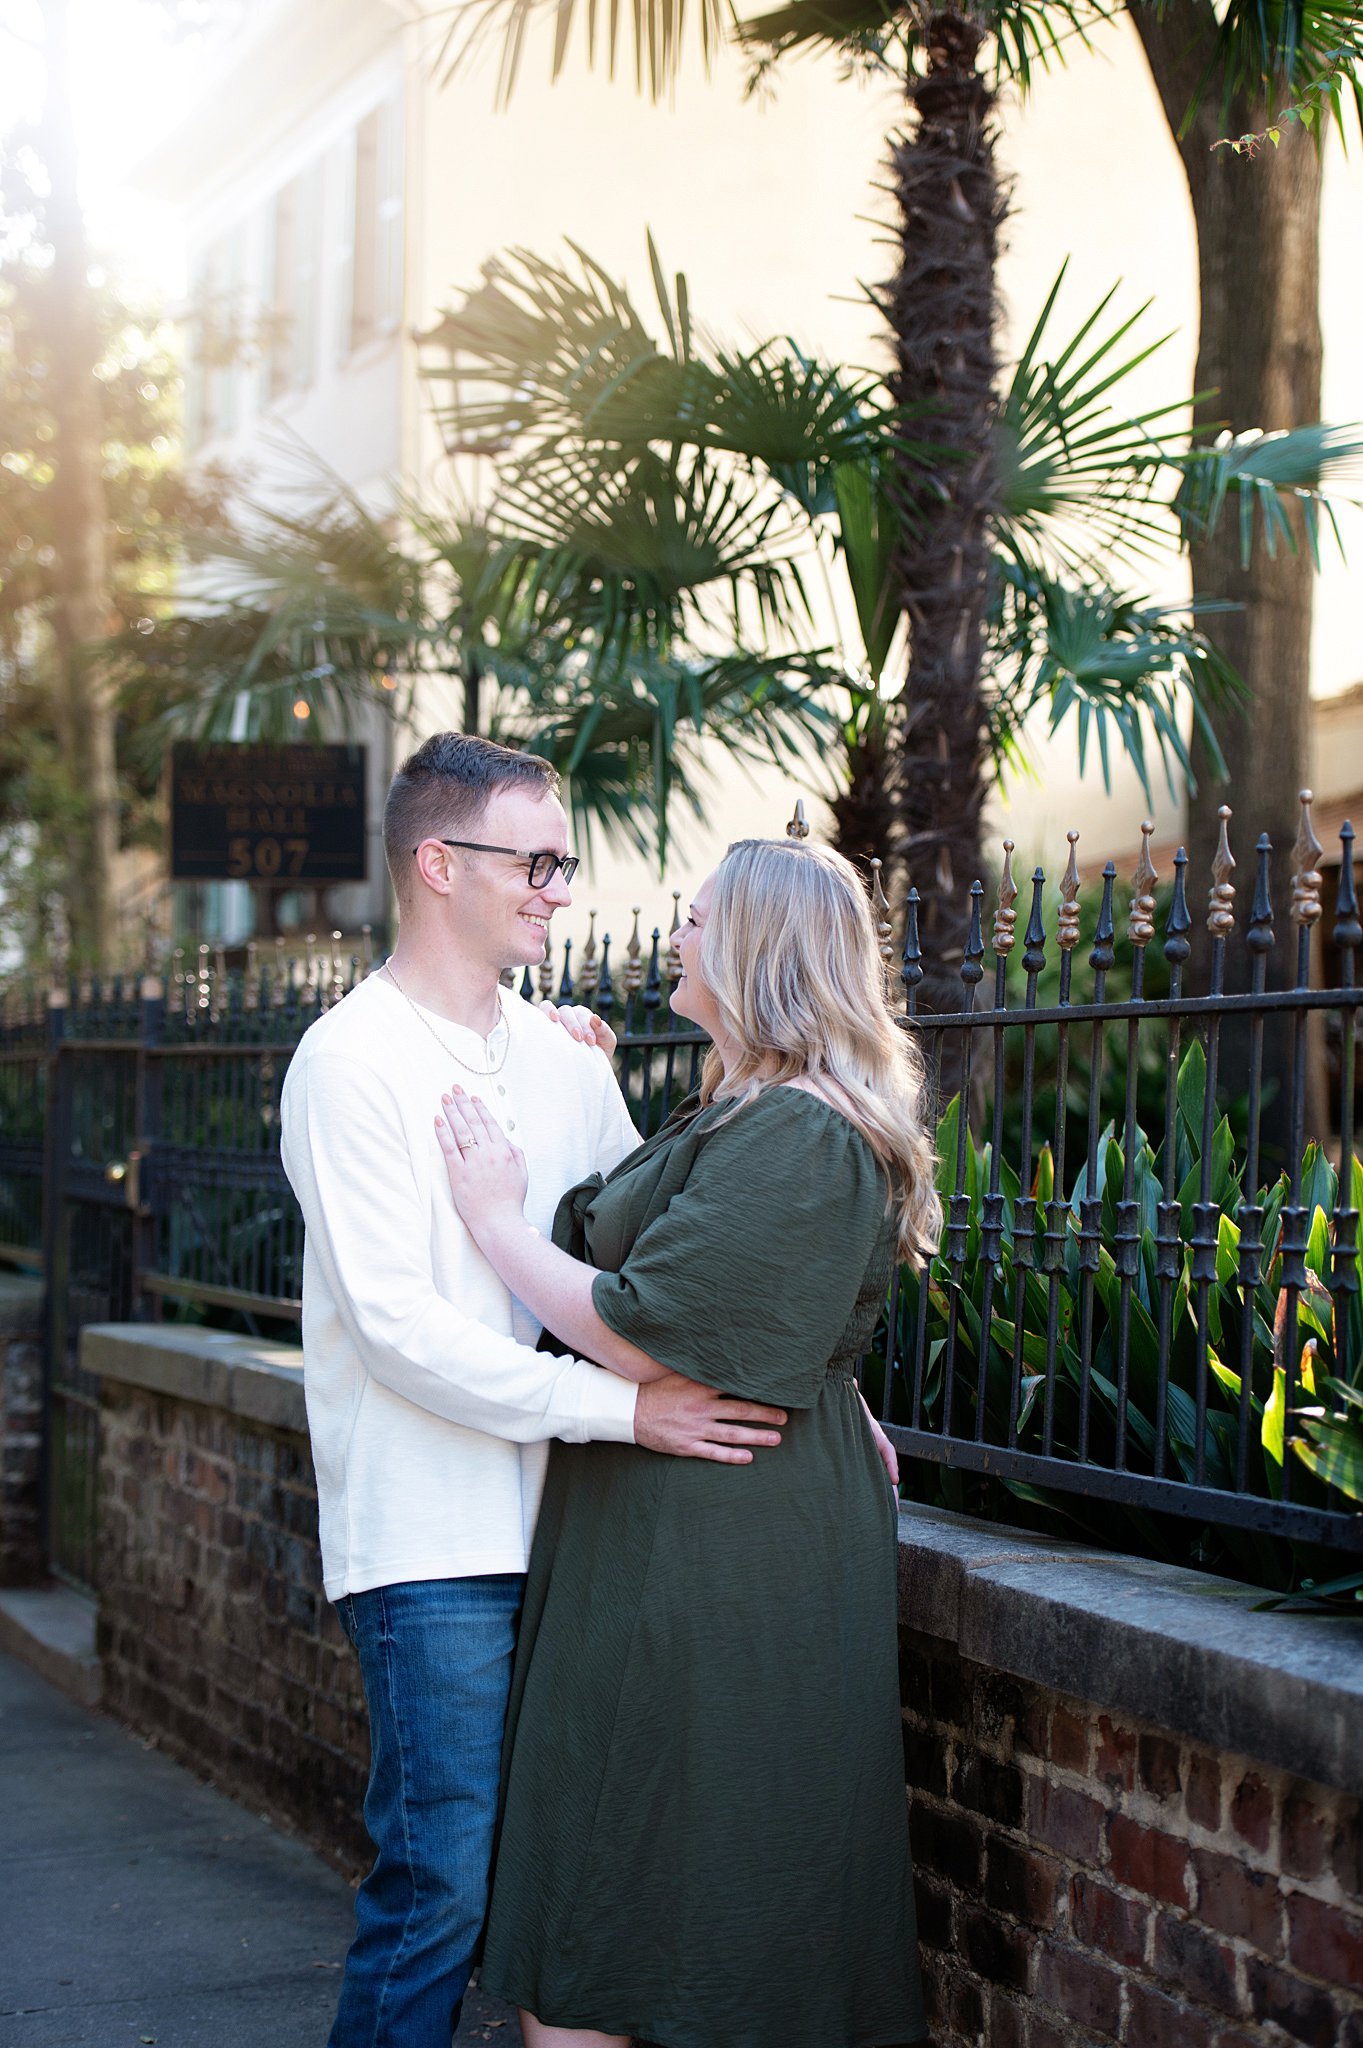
[{"xmin": 98, "ymin": 1380, "xmax": 372, "ymax": 1872}]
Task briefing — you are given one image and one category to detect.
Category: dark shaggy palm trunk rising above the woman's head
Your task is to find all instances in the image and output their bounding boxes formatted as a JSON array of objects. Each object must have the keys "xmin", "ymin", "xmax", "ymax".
[{"xmin": 886, "ymin": 12, "xmax": 1007, "ymax": 1032}]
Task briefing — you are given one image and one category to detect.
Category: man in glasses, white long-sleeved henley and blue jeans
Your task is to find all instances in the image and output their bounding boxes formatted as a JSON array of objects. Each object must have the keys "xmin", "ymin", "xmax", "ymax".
[{"xmin": 282, "ymin": 733, "xmax": 786, "ymax": 2048}]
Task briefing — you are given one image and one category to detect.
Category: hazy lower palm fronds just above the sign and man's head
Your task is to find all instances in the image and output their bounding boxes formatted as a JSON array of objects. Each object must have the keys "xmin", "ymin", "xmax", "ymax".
[{"xmin": 114, "ymin": 471, "xmax": 835, "ymax": 868}]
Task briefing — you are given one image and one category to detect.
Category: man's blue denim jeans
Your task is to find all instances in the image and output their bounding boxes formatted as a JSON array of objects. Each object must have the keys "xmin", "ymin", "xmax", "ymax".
[{"xmin": 329, "ymin": 1573, "xmax": 524, "ymax": 2048}]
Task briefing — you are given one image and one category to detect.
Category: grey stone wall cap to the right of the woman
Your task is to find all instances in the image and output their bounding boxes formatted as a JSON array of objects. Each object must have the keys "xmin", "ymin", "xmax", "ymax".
[{"xmin": 898, "ymin": 1505, "xmax": 1363, "ymax": 1794}]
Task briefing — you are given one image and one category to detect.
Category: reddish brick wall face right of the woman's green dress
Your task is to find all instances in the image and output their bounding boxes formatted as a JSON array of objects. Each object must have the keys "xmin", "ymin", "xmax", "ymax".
[{"xmin": 900, "ymin": 1622, "xmax": 1363, "ymax": 2048}]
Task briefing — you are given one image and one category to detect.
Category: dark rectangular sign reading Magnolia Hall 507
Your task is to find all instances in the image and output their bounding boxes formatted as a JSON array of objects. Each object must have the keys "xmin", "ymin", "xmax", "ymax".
[{"xmin": 170, "ymin": 741, "xmax": 368, "ymax": 887}]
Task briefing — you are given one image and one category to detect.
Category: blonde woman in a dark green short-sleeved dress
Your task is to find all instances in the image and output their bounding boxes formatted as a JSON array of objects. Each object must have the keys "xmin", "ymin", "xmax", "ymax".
[{"xmin": 438, "ymin": 840, "xmax": 939, "ymax": 2048}]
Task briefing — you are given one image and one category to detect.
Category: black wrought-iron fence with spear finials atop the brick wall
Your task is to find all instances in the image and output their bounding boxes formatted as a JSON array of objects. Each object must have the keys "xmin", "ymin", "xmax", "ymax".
[{"xmin": 0, "ymin": 801, "xmax": 1363, "ymax": 1577}]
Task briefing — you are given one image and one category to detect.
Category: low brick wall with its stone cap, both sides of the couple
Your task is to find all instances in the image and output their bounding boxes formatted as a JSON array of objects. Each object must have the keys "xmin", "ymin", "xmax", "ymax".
[{"xmin": 82, "ymin": 1325, "xmax": 1363, "ymax": 2048}]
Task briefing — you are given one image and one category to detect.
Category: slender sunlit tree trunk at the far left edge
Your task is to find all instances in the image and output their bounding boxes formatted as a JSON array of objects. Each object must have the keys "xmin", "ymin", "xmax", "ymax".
[{"xmin": 43, "ymin": 0, "xmax": 119, "ymax": 967}]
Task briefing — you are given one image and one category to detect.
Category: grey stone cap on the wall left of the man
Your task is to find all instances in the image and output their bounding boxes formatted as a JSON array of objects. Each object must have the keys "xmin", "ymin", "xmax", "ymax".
[{"xmin": 80, "ymin": 1323, "xmax": 307, "ymax": 1434}]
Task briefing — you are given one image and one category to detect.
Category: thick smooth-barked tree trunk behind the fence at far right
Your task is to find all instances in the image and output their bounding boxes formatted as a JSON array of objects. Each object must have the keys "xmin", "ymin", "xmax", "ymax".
[{"xmin": 1132, "ymin": 0, "xmax": 1320, "ymax": 985}]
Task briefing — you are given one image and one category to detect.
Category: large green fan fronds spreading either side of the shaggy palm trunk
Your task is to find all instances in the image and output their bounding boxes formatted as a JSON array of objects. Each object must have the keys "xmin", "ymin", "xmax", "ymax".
[{"xmin": 424, "ymin": 246, "xmax": 1363, "ymax": 997}]
